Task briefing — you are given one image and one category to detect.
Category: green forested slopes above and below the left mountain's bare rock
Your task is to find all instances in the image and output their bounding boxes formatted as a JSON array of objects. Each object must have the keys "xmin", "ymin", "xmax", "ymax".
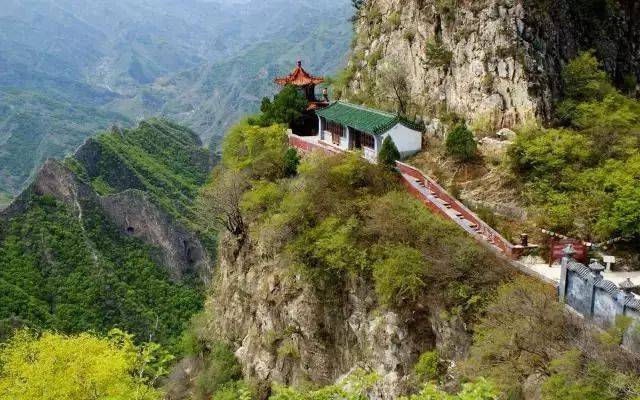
[{"xmin": 0, "ymin": 120, "xmax": 208, "ymax": 344}]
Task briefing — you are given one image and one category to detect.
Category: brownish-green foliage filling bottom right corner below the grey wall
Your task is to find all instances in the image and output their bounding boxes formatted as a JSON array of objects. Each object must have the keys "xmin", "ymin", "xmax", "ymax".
[{"xmin": 464, "ymin": 277, "xmax": 640, "ymax": 400}]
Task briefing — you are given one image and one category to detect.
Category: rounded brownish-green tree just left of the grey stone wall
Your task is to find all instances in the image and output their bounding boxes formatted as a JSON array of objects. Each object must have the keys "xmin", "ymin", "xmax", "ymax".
[{"xmin": 468, "ymin": 277, "xmax": 579, "ymax": 392}]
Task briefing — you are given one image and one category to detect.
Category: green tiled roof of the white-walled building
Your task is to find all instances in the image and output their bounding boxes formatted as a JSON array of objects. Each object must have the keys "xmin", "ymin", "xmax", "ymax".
[{"xmin": 316, "ymin": 101, "xmax": 402, "ymax": 135}]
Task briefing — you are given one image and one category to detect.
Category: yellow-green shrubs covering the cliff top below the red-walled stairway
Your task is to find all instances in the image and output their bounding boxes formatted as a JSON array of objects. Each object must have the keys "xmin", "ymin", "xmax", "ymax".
[{"xmin": 232, "ymin": 145, "xmax": 505, "ymax": 312}]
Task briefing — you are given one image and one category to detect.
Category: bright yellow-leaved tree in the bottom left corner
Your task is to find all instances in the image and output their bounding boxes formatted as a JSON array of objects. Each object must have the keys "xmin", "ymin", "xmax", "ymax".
[{"xmin": 0, "ymin": 331, "xmax": 161, "ymax": 400}]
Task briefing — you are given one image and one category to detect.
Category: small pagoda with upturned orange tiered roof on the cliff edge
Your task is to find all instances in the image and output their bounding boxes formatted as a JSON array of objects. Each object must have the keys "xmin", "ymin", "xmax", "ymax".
[{"xmin": 274, "ymin": 61, "xmax": 329, "ymax": 136}]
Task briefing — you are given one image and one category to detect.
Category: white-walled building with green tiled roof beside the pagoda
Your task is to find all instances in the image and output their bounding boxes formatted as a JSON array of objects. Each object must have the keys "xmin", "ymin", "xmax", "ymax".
[{"xmin": 316, "ymin": 101, "xmax": 422, "ymax": 161}]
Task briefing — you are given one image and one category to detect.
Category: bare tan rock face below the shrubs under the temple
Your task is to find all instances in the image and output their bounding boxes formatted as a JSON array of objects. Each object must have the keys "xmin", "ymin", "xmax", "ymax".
[{"xmin": 208, "ymin": 237, "xmax": 469, "ymax": 399}]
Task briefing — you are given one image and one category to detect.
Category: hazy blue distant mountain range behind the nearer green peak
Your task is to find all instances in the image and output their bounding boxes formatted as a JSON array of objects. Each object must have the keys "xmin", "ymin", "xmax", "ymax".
[{"xmin": 0, "ymin": 0, "xmax": 351, "ymax": 199}]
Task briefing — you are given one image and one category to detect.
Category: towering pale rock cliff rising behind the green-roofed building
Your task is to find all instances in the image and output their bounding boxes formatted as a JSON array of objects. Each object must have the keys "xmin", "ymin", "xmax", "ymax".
[{"xmin": 346, "ymin": 0, "xmax": 640, "ymax": 128}]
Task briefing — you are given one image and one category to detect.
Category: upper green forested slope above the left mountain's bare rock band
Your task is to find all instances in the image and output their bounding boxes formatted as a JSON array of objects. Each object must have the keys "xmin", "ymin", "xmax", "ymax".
[{"xmin": 67, "ymin": 119, "xmax": 209, "ymax": 223}]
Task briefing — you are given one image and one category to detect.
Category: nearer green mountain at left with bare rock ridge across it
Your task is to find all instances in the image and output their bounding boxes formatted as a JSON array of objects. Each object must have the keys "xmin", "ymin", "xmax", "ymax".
[{"xmin": 0, "ymin": 120, "xmax": 213, "ymax": 345}]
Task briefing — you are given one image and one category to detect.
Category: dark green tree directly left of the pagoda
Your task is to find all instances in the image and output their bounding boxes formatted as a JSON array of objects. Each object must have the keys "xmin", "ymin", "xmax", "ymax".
[{"xmin": 259, "ymin": 85, "xmax": 309, "ymax": 128}]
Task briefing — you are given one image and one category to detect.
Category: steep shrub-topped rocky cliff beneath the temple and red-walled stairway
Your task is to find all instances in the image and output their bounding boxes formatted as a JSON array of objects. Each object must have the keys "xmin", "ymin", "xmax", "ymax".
[{"xmin": 181, "ymin": 137, "xmax": 510, "ymax": 399}]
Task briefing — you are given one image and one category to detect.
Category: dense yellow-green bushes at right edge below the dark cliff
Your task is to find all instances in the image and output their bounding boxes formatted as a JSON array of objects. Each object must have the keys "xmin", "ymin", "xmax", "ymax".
[{"xmin": 510, "ymin": 53, "xmax": 640, "ymax": 240}]
